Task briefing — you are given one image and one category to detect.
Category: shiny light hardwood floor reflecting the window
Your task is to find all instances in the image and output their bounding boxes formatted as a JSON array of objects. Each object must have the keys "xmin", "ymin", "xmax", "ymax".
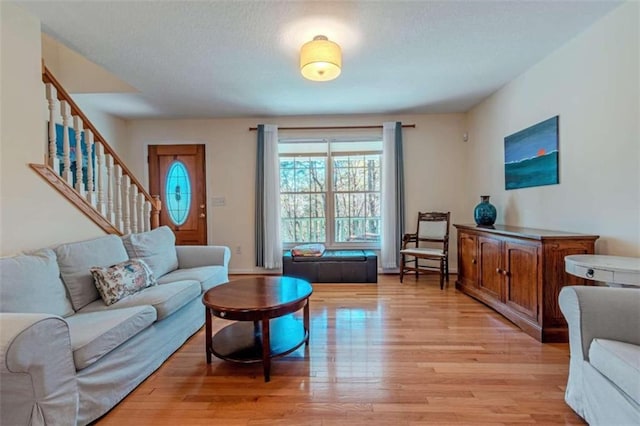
[{"xmin": 97, "ymin": 275, "xmax": 584, "ymax": 426}]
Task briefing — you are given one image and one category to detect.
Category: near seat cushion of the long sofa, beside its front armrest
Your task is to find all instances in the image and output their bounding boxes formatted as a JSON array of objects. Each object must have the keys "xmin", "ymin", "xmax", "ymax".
[{"xmin": 66, "ymin": 301, "xmax": 156, "ymax": 370}]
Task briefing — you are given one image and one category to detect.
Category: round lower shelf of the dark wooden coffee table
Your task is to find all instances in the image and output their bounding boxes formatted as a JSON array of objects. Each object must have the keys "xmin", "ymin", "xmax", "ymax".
[{"xmin": 211, "ymin": 314, "xmax": 309, "ymax": 363}]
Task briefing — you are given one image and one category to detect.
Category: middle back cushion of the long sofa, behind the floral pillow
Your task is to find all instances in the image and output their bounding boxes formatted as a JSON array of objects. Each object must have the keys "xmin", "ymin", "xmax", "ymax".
[{"xmin": 55, "ymin": 235, "xmax": 129, "ymax": 310}]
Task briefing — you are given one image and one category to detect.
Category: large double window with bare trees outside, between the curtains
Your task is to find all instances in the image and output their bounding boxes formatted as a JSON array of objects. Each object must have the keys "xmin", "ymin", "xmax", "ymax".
[{"xmin": 278, "ymin": 139, "xmax": 382, "ymax": 247}]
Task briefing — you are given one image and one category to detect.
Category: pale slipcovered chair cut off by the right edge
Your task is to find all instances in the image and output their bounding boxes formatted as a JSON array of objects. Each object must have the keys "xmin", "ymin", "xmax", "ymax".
[{"xmin": 559, "ymin": 286, "xmax": 640, "ymax": 426}]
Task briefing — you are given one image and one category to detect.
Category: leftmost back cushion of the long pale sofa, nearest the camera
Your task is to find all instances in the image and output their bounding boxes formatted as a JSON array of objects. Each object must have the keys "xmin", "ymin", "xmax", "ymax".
[{"xmin": 0, "ymin": 249, "xmax": 73, "ymax": 317}]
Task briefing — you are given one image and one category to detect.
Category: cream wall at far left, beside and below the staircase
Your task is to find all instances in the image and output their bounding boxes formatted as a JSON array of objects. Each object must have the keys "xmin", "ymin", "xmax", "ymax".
[{"xmin": 0, "ymin": 2, "xmax": 103, "ymax": 255}]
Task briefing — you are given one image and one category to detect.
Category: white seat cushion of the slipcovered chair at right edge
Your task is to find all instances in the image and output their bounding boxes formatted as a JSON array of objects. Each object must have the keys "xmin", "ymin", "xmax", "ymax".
[{"xmin": 589, "ymin": 339, "xmax": 640, "ymax": 403}]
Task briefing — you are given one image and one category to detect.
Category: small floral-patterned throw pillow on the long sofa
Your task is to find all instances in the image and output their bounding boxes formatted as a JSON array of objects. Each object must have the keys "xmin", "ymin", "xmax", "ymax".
[{"xmin": 89, "ymin": 259, "xmax": 158, "ymax": 305}]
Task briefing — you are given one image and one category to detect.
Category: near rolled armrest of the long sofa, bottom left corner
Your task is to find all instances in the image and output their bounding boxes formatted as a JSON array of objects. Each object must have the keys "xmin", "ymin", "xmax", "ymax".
[{"xmin": 0, "ymin": 313, "xmax": 78, "ymax": 425}]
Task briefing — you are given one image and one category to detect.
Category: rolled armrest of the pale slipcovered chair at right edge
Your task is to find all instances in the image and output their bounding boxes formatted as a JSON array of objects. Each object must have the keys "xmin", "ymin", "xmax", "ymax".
[{"xmin": 559, "ymin": 286, "xmax": 640, "ymax": 360}]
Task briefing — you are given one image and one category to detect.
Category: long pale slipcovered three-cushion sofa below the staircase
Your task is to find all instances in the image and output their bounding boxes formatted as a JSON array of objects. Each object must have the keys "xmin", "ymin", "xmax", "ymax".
[{"xmin": 0, "ymin": 227, "xmax": 231, "ymax": 426}]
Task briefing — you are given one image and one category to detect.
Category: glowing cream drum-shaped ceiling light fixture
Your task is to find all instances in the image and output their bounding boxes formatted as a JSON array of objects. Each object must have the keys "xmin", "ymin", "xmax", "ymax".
[{"xmin": 300, "ymin": 35, "xmax": 342, "ymax": 81}]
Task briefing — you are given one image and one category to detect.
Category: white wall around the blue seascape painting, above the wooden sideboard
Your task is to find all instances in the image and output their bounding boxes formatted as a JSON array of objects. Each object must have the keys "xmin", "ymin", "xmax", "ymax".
[{"xmin": 463, "ymin": 2, "xmax": 640, "ymax": 256}]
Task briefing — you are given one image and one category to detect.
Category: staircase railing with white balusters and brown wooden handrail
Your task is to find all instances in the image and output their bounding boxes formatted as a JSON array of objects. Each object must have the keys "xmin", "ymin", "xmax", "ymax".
[{"xmin": 29, "ymin": 65, "xmax": 161, "ymax": 235}]
